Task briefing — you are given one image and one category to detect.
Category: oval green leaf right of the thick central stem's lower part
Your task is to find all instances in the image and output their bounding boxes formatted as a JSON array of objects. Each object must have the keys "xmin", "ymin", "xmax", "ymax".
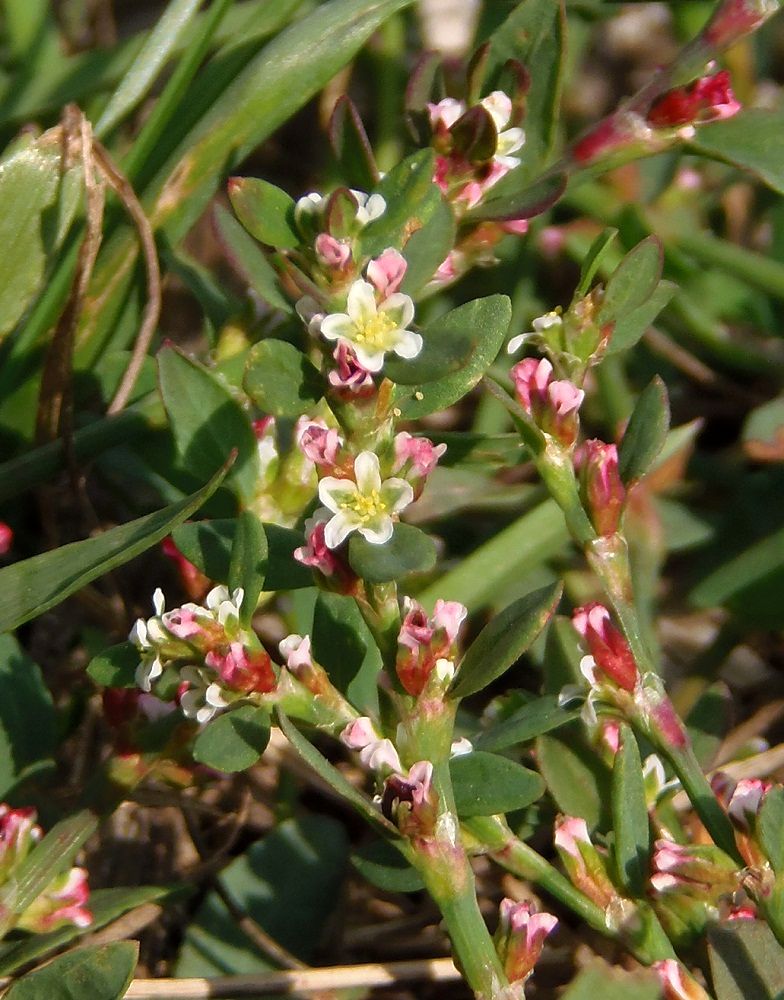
[{"xmin": 449, "ymin": 750, "xmax": 545, "ymax": 818}]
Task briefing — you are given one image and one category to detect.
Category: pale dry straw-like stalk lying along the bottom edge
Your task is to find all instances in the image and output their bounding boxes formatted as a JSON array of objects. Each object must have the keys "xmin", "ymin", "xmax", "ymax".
[{"xmin": 125, "ymin": 958, "xmax": 460, "ymax": 1000}]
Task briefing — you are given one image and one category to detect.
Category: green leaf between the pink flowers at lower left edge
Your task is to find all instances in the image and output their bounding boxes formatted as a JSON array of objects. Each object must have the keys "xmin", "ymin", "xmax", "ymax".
[{"xmin": 0, "ymin": 810, "xmax": 98, "ymax": 927}]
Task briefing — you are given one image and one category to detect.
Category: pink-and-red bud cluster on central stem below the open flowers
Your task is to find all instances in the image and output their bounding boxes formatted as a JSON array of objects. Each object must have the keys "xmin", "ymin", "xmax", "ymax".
[{"xmin": 396, "ymin": 597, "xmax": 468, "ymax": 697}]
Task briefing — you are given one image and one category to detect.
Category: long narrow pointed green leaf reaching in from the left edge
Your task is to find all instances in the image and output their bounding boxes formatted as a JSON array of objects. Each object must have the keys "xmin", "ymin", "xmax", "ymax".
[{"xmin": 0, "ymin": 468, "xmax": 226, "ymax": 632}]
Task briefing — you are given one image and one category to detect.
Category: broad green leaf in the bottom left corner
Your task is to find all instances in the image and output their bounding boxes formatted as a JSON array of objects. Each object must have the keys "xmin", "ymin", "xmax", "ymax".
[{"xmin": 5, "ymin": 941, "xmax": 139, "ymax": 1000}]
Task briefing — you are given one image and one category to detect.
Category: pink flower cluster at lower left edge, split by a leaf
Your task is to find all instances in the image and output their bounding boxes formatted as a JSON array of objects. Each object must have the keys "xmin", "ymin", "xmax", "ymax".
[{"xmin": 0, "ymin": 802, "xmax": 93, "ymax": 934}]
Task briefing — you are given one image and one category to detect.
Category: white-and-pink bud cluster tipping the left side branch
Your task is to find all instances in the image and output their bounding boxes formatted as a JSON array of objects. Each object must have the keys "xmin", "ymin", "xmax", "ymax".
[{"xmin": 129, "ymin": 586, "xmax": 276, "ymax": 723}]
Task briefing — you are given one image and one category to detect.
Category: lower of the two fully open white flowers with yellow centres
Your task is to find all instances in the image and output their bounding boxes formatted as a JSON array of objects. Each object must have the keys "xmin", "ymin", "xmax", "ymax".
[{"xmin": 319, "ymin": 451, "xmax": 414, "ymax": 549}]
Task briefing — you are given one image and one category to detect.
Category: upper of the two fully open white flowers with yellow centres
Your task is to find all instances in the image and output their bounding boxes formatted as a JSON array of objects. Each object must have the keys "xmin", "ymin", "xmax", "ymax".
[{"xmin": 321, "ymin": 280, "xmax": 422, "ymax": 372}]
